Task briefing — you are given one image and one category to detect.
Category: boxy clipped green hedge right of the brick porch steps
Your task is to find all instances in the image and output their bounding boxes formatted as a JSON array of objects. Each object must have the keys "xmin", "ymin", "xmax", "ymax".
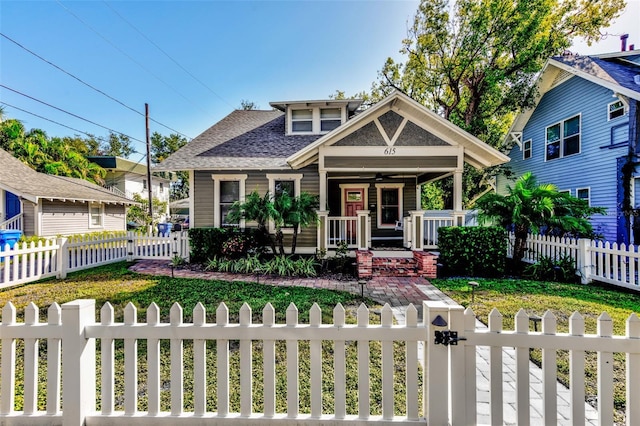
[{"xmin": 438, "ymin": 226, "xmax": 507, "ymax": 277}]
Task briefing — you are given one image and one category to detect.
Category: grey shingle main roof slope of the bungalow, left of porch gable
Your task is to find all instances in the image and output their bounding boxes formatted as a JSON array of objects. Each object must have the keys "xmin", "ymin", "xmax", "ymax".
[{"xmin": 154, "ymin": 110, "xmax": 321, "ymax": 170}]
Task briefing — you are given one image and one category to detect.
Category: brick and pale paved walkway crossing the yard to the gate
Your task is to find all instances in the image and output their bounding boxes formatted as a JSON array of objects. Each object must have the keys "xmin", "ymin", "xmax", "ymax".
[{"xmin": 130, "ymin": 260, "xmax": 598, "ymax": 426}]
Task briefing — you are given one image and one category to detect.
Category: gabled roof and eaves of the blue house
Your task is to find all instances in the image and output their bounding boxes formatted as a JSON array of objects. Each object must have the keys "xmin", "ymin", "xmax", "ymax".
[{"xmin": 509, "ymin": 50, "xmax": 640, "ymax": 134}]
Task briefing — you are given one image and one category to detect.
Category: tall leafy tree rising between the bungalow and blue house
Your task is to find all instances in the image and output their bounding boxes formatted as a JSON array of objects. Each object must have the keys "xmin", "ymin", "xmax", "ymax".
[{"xmin": 372, "ymin": 0, "xmax": 624, "ymax": 205}]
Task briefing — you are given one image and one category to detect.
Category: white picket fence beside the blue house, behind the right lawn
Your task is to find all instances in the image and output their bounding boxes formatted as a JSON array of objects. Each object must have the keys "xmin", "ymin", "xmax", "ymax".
[{"xmin": 507, "ymin": 234, "xmax": 640, "ymax": 291}]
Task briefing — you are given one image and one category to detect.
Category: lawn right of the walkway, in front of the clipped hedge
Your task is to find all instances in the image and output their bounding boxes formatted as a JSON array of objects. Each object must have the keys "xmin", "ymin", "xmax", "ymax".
[{"xmin": 432, "ymin": 279, "xmax": 640, "ymax": 421}]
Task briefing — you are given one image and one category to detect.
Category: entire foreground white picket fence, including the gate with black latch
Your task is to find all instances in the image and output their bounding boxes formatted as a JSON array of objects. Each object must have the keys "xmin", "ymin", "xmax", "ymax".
[{"xmin": 0, "ymin": 300, "xmax": 640, "ymax": 426}]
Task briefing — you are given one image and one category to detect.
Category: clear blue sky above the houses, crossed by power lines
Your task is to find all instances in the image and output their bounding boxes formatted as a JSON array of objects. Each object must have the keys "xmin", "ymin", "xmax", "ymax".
[{"xmin": 0, "ymin": 0, "xmax": 640, "ymax": 160}]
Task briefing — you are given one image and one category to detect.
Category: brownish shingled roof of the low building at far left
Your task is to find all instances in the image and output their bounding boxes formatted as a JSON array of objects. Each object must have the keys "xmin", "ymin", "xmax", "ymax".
[{"xmin": 0, "ymin": 149, "xmax": 137, "ymax": 204}]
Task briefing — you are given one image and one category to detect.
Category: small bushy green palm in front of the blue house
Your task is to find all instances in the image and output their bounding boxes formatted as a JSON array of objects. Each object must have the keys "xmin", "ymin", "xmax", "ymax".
[{"xmin": 476, "ymin": 172, "xmax": 606, "ymax": 267}]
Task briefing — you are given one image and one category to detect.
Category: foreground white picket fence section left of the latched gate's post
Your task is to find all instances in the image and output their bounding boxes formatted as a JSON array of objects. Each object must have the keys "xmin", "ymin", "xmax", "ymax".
[{"xmin": 0, "ymin": 300, "xmax": 427, "ymax": 426}]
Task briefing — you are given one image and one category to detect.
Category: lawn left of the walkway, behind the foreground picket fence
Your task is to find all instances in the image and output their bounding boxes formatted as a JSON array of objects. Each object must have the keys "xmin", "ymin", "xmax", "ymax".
[{"xmin": 0, "ymin": 262, "xmax": 422, "ymax": 415}]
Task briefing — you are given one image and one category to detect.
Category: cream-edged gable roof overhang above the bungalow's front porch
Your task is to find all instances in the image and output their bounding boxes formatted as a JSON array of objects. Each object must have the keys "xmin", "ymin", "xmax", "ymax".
[{"xmin": 287, "ymin": 90, "xmax": 509, "ymax": 168}]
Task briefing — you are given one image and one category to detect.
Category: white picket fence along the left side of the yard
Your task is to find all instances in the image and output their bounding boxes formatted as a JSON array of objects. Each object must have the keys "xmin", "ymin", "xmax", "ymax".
[{"xmin": 0, "ymin": 231, "xmax": 189, "ymax": 288}]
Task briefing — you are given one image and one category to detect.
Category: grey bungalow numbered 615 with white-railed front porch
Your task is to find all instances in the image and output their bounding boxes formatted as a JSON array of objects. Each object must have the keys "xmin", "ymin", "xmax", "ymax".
[{"xmin": 154, "ymin": 91, "xmax": 509, "ymax": 260}]
